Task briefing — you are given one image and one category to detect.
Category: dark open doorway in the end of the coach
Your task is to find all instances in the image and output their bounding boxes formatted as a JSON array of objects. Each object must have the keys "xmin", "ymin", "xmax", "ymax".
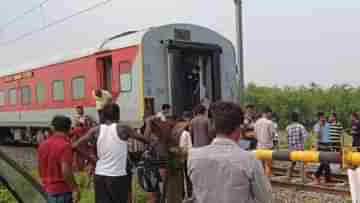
[{"xmin": 168, "ymin": 42, "xmax": 221, "ymax": 115}]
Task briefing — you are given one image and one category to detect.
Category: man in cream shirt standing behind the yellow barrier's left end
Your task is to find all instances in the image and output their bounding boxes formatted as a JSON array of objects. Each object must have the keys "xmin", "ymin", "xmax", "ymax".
[{"xmin": 255, "ymin": 107, "xmax": 275, "ymax": 177}]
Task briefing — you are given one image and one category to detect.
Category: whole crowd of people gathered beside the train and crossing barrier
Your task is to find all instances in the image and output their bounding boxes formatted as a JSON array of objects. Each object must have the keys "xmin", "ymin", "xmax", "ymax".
[{"xmin": 38, "ymin": 87, "xmax": 360, "ymax": 203}]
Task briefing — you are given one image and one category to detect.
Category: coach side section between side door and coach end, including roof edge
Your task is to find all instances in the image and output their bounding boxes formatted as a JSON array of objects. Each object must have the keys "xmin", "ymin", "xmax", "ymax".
[{"xmin": 99, "ymin": 29, "xmax": 148, "ymax": 127}]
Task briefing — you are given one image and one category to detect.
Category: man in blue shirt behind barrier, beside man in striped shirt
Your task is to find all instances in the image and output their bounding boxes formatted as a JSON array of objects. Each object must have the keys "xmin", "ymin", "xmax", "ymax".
[{"xmin": 313, "ymin": 112, "xmax": 331, "ymax": 185}]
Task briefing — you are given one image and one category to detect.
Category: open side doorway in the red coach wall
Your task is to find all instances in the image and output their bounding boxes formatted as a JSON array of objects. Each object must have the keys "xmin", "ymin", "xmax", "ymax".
[{"xmin": 98, "ymin": 56, "xmax": 113, "ymax": 92}]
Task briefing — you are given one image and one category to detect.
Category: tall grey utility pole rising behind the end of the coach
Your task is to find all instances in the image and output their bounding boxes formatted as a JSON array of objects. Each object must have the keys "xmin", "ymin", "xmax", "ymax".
[{"xmin": 234, "ymin": 0, "xmax": 245, "ymax": 105}]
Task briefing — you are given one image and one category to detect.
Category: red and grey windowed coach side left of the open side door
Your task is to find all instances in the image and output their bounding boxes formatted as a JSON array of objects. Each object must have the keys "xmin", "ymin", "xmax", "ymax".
[{"xmin": 0, "ymin": 56, "xmax": 96, "ymax": 127}]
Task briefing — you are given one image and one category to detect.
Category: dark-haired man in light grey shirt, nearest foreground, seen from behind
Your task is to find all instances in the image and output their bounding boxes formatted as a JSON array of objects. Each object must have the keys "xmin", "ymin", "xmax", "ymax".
[{"xmin": 188, "ymin": 102, "xmax": 272, "ymax": 203}]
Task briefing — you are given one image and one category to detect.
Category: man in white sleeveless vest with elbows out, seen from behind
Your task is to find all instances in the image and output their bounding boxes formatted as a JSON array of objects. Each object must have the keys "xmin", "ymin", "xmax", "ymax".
[{"xmin": 73, "ymin": 104, "xmax": 148, "ymax": 203}]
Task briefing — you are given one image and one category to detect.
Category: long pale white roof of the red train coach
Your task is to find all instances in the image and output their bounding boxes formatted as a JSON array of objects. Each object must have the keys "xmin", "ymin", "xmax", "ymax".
[{"xmin": 0, "ymin": 29, "xmax": 150, "ymax": 76}]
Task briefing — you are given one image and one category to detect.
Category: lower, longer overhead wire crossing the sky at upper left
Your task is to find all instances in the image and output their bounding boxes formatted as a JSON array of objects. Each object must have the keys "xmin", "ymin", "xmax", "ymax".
[{"xmin": 0, "ymin": 0, "xmax": 113, "ymax": 46}]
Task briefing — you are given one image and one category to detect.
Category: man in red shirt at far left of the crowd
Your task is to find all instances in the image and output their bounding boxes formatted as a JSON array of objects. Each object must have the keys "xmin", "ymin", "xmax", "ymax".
[{"xmin": 38, "ymin": 116, "xmax": 80, "ymax": 203}]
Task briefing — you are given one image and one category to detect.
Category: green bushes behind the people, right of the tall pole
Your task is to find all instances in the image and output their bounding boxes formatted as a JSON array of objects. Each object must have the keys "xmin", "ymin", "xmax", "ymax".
[{"xmin": 245, "ymin": 83, "xmax": 360, "ymax": 128}]
